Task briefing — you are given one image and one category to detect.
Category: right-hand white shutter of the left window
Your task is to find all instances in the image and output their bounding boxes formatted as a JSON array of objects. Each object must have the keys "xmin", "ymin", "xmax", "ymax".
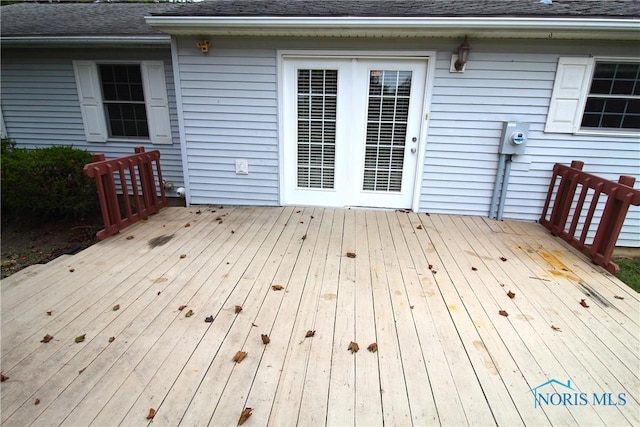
[{"xmin": 141, "ymin": 61, "xmax": 173, "ymax": 144}]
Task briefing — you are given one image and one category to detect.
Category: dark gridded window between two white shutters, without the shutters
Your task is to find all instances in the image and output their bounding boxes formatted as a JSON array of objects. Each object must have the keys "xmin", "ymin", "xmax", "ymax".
[{"xmin": 98, "ymin": 64, "xmax": 149, "ymax": 138}]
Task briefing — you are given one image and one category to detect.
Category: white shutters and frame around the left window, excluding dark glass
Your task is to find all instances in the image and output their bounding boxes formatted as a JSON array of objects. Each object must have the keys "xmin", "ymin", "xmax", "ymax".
[{"xmin": 73, "ymin": 61, "xmax": 173, "ymax": 144}]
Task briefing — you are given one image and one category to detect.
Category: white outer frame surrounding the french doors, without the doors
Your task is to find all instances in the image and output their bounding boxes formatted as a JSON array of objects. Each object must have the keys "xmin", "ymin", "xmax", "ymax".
[{"xmin": 276, "ymin": 50, "xmax": 436, "ymax": 211}]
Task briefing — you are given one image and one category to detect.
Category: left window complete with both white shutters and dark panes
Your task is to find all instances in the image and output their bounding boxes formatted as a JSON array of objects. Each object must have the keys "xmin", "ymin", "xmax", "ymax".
[{"xmin": 73, "ymin": 61, "xmax": 172, "ymax": 144}]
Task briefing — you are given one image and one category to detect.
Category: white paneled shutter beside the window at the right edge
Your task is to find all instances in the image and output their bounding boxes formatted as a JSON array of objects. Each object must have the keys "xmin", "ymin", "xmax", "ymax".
[{"xmin": 544, "ymin": 57, "xmax": 593, "ymax": 133}]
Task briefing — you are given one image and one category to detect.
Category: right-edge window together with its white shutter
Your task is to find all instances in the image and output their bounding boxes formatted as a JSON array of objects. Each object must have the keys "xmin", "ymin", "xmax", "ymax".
[{"xmin": 545, "ymin": 57, "xmax": 640, "ymax": 133}]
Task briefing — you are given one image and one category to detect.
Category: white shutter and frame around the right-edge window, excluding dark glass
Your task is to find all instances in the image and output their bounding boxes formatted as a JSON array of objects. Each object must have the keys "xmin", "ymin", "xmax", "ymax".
[{"xmin": 544, "ymin": 56, "xmax": 640, "ymax": 138}]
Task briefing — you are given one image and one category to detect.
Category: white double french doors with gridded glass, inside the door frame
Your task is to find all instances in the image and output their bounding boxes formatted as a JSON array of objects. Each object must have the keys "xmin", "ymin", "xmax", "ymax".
[{"xmin": 283, "ymin": 58, "xmax": 427, "ymax": 208}]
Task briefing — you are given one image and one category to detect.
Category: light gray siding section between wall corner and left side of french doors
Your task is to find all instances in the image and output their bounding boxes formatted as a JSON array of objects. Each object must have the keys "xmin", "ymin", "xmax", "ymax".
[{"xmin": 178, "ymin": 39, "xmax": 279, "ymax": 205}]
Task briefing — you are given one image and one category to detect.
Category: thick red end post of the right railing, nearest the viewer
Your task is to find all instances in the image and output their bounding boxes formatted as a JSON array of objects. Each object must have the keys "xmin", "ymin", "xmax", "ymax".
[{"xmin": 590, "ymin": 175, "xmax": 636, "ymax": 273}]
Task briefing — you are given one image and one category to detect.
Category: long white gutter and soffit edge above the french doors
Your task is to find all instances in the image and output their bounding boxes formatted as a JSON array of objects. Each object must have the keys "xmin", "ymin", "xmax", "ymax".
[{"xmin": 145, "ymin": 16, "xmax": 640, "ymax": 40}]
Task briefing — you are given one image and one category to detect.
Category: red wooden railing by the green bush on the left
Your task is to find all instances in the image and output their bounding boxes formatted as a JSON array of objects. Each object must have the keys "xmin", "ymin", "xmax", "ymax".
[{"xmin": 84, "ymin": 147, "xmax": 167, "ymax": 239}]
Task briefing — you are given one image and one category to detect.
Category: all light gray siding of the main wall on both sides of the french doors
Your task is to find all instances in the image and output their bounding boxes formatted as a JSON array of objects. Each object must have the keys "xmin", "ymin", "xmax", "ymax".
[{"xmin": 178, "ymin": 37, "xmax": 640, "ymax": 247}]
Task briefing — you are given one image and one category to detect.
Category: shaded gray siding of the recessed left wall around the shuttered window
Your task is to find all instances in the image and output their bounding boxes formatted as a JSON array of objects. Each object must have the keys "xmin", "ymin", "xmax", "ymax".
[{"xmin": 1, "ymin": 46, "xmax": 184, "ymax": 195}]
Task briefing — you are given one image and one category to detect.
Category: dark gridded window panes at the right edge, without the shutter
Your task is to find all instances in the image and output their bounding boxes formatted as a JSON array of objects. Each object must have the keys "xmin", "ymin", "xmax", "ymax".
[{"xmin": 581, "ymin": 62, "xmax": 640, "ymax": 130}]
